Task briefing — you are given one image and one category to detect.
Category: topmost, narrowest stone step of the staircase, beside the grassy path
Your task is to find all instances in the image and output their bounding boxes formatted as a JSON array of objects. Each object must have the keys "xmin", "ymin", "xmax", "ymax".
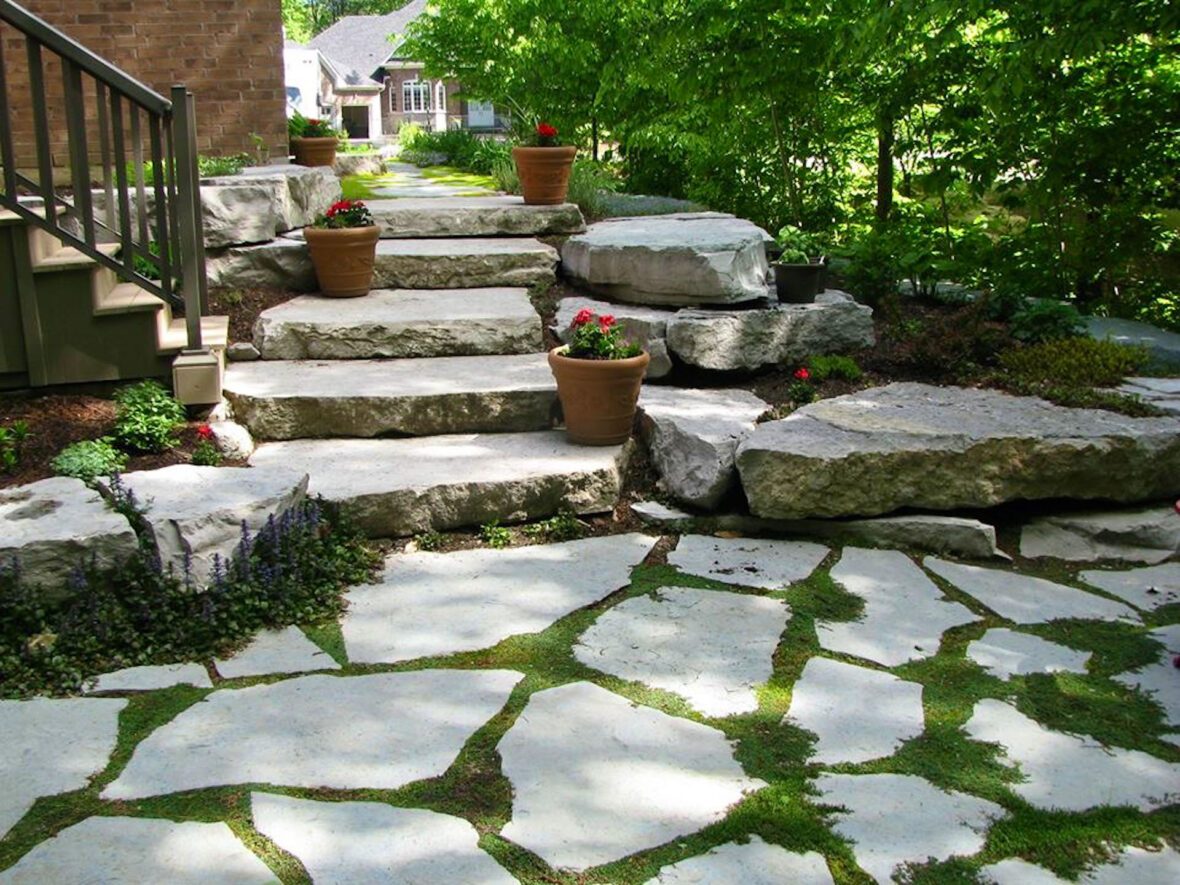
[{"xmin": 365, "ymin": 196, "xmax": 586, "ymax": 240}]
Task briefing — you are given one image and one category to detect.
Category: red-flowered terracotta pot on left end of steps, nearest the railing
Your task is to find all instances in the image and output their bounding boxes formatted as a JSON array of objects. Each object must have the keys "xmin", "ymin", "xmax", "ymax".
[{"xmin": 303, "ymin": 199, "xmax": 381, "ymax": 299}]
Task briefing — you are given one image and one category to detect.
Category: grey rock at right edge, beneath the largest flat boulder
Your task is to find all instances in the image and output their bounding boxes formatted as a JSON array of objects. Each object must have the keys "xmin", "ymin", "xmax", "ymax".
[{"xmin": 1021, "ymin": 504, "xmax": 1180, "ymax": 565}]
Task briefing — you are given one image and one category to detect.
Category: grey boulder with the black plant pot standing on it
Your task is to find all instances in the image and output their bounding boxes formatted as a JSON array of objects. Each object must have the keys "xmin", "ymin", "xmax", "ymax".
[{"xmin": 668, "ymin": 291, "xmax": 874, "ymax": 372}]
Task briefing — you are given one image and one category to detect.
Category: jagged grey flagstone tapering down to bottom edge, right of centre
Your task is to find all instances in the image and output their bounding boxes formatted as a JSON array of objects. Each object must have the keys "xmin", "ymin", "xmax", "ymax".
[{"xmin": 815, "ymin": 774, "xmax": 1004, "ymax": 885}]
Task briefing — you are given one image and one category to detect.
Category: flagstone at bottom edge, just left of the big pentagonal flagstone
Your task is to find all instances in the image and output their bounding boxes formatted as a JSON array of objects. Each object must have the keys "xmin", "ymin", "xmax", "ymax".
[{"xmin": 250, "ymin": 793, "xmax": 517, "ymax": 885}]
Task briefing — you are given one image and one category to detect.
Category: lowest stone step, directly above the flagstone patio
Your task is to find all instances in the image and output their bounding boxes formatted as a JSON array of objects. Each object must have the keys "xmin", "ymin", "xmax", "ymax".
[{"xmin": 250, "ymin": 431, "xmax": 631, "ymax": 537}]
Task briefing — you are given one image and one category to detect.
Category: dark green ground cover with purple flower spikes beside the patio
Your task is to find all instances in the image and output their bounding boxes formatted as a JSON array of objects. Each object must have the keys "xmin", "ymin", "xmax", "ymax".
[{"xmin": 0, "ymin": 487, "xmax": 374, "ymax": 697}]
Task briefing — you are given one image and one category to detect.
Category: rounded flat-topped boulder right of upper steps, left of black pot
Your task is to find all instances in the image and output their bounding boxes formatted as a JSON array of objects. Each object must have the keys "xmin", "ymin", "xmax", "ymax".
[{"xmin": 562, "ymin": 216, "xmax": 768, "ymax": 307}]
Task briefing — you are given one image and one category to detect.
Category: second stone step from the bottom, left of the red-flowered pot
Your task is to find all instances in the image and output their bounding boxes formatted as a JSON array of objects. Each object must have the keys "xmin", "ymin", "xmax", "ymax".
[{"xmin": 223, "ymin": 353, "xmax": 557, "ymax": 439}]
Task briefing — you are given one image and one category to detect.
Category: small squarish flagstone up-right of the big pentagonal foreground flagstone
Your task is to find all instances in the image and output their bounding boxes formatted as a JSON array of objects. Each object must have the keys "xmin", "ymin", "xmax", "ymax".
[{"xmin": 784, "ymin": 657, "xmax": 925, "ymax": 765}]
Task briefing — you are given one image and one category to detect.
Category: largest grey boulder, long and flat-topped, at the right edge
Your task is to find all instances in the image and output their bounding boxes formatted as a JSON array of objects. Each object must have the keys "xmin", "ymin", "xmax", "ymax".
[{"xmin": 738, "ymin": 384, "xmax": 1180, "ymax": 518}]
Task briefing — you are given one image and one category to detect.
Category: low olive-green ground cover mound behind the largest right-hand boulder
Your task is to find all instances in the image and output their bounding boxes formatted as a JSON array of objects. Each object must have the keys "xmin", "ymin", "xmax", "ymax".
[{"xmin": 999, "ymin": 337, "xmax": 1148, "ymax": 387}]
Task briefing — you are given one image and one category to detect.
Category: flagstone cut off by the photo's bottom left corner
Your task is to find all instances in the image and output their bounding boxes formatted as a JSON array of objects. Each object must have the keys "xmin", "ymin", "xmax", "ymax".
[{"xmin": 0, "ymin": 818, "xmax": 275, "ymax": 885}]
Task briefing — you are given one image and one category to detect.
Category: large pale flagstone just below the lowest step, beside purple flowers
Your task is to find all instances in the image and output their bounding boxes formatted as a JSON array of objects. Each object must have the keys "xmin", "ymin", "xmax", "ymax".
[{"xmin": 341, "ymin": 535, "xmax": 656, "ymax": 663}]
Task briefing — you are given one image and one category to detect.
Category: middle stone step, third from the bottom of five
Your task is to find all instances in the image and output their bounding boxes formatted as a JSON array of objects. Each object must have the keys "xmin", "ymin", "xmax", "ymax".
[{"xmin": 254, "ymin": 288, "xmax": 543, "ymax": 360}]
